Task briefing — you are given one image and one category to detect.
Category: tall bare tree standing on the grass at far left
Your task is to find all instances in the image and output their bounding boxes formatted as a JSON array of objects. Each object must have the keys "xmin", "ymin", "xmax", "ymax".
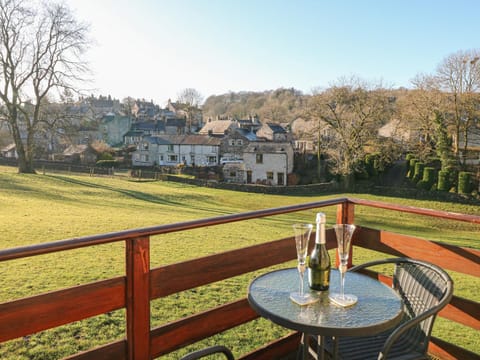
[{"xmin": 0, "ymin": 0, "xmax": 89, "ymax": 173}]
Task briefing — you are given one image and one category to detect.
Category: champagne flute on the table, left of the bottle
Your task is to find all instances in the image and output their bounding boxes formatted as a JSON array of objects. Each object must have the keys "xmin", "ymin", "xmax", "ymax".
[{"xmin": 290, "ymin": 224, "xmax": 319, "ymax": 306}]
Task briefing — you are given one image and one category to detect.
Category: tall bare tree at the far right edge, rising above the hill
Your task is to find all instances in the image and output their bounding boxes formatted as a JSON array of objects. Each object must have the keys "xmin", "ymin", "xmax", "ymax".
[{"xmin": 436, "ymin": 50, "xmax": 480, "ymax": 165}]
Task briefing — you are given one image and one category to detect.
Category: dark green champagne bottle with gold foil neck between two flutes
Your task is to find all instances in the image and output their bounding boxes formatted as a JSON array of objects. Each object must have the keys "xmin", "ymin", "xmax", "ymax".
[{"xmin": 308, "ymin": 213, "xmax": 331, "ymax": 291}]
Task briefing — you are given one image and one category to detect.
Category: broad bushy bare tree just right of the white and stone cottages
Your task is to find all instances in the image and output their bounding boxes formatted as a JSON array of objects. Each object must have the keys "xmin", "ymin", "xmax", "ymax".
[{"xmin": 307, "ymin": 78, "xmax": 390, "ymax": 189}]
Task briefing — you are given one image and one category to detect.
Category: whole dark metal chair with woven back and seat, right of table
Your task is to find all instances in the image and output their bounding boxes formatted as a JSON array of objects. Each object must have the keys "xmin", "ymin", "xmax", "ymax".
[{"xmin": 327, "ymin": 258, "xmax": 453, "ymax": 360}]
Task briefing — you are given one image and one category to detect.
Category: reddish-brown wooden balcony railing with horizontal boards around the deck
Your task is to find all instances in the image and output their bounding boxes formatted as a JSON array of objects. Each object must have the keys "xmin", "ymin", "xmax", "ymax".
[{"xmin": 0, "ymin": 198, "xmax": 480, "ymax": 360}]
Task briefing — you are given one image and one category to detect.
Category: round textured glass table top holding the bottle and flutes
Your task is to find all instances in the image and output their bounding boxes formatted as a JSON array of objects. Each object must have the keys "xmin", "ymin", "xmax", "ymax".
[{"xmin": 248, "ymin": 268, "xmax": 403, "ymax": 336}]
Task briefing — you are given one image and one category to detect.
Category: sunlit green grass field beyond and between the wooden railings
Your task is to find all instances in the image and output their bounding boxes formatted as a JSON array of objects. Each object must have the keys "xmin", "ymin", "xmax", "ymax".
[{"xmin": 0, "ymin": 167, "xmax": 480, "ymax": 360}]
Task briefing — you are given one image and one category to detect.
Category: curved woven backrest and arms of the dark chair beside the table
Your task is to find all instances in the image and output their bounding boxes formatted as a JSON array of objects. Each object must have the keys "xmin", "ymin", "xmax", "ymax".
[{"xmin": 350, "ymin": 258, "xmax": 453, "ymax": 356}]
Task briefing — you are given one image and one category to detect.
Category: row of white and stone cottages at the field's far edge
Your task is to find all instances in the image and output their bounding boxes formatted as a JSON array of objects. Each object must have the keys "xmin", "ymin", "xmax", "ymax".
[{"xmin": 132, "ymin": 120, "xmax": 294, "ymax": 185}]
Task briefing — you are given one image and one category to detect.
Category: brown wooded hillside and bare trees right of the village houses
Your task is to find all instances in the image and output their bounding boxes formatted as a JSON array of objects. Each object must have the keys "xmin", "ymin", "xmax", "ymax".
[{"xmin": 203, "ymin": 54, "xmax": 480, "ymax": 194}]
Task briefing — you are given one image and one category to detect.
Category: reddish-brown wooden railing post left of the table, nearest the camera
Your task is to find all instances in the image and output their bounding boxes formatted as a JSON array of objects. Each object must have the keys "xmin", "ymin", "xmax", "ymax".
[{"xmin": 126, "ymin": 236, "xmax": 150, "ymax": 360}]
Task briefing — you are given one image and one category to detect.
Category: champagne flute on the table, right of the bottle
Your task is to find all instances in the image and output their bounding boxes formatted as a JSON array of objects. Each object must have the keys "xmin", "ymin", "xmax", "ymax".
[{"xmin": 329, "ymin": 224, "xmax": 358, "ymax": 307}]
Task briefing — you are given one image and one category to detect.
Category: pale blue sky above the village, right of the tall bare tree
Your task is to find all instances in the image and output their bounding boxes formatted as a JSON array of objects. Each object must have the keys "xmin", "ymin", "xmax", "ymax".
[{"xmin": 65, "ymin": 0, "xmax": 480, "ymax": 105}]
